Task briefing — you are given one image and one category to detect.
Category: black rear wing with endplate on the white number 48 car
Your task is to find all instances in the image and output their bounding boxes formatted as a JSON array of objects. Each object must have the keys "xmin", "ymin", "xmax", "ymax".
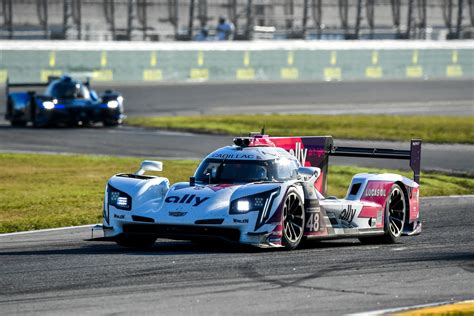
[{"xmin": 329, "ymin": 139, "xmax": 421, "ymax": 183}]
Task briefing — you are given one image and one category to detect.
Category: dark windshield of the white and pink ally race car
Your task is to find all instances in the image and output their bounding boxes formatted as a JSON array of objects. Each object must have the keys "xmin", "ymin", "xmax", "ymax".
[{"xmin": 196, "ymin": 159, "xmax": 298, "ymax": 184}]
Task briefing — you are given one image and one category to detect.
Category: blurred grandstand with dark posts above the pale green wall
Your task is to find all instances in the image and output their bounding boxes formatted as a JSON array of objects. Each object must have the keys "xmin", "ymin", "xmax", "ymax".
[{"xmin": 0, "ymin": 0, "xmax": 474, "ymax": 41}]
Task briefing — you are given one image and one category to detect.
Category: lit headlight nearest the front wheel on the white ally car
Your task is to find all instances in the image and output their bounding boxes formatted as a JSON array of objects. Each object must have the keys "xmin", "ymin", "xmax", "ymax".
[{"xmin": 229, "ymin": 188, "xmax": 280, "ymax": 214}]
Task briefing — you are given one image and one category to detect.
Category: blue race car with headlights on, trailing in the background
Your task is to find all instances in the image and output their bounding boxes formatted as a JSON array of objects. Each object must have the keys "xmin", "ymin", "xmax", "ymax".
[{"xmin": 5, "ymin": 76, "xmax": 125, "ymax": 127}]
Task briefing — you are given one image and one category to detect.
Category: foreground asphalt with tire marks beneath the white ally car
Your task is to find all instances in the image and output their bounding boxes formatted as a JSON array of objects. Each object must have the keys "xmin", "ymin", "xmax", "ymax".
[{"xmin": 0, "ymin": 196, "xmax": 474, "ymax": 315}]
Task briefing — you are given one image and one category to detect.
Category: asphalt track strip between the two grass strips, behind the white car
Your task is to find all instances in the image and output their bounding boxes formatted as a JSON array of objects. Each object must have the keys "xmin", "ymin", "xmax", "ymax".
[{"xmin": 0, "ymin": 125, "xmax": 474, "ymax": 174}]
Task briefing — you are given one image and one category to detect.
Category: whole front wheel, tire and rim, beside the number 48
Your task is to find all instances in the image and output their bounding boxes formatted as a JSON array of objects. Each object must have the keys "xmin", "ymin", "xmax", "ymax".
[{"xmin": 282, "ymin": 188, "xmax": 305, "ymax": 250}]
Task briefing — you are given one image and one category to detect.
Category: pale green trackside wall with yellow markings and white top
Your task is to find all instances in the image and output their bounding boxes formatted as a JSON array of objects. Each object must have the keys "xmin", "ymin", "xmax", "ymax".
[{"xmin": 0, "ymin": 41, "xmax": 474, "ymax": 82}]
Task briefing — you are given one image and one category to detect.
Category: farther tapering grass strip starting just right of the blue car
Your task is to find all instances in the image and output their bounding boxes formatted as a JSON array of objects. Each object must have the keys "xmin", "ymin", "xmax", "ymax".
[{"xmin": 126, "ymin": 114, "xmax": 474, "ymax": 144}]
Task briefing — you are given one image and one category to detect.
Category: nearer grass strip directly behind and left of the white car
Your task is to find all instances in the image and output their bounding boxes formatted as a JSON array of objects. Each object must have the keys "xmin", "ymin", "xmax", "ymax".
[{"xmin": 0, "ymin": 154, "xmax": 474, "ymax": 233}]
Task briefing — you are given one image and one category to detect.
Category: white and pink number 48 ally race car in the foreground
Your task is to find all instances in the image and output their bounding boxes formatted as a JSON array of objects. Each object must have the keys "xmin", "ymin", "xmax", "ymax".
[{"xmin": 93, "ymin": 133, "xmax": 421, "ymax": 249}]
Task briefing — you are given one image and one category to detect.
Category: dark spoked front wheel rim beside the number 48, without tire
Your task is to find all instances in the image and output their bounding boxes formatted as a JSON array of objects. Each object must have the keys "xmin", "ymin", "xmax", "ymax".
[{"xmin": 283, "ymin": 193, "xmax": 304, "ymax": 243}]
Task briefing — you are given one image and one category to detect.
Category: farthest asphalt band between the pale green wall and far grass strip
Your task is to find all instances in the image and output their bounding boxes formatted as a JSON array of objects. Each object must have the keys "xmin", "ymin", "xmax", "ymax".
[{"xmin": 0, "ymin": 80, "xmax": 474, "ymax": 116}]
